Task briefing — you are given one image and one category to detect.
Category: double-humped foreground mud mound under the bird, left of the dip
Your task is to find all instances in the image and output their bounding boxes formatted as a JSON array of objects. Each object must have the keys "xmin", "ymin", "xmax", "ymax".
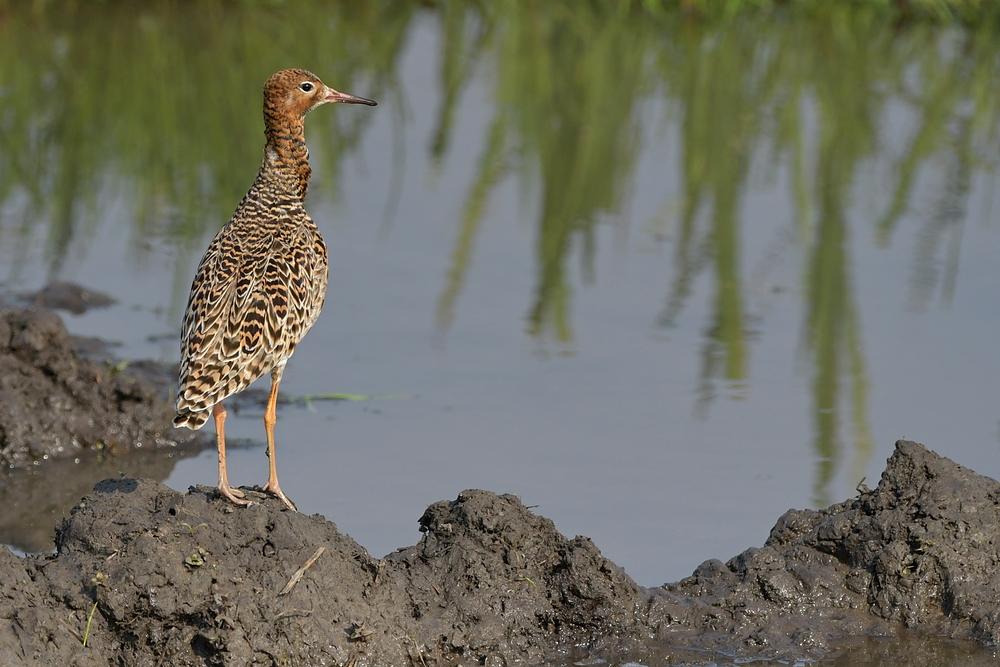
[{"xmin": 25, "ymin": 479, "xmax": 644, "ymax": 665}]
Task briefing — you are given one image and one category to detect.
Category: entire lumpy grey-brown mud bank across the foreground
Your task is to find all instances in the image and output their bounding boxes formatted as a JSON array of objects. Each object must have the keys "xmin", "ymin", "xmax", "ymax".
[{"xmin": 0, "ymin": 441, "xmax": 1000, "ymax": 667}]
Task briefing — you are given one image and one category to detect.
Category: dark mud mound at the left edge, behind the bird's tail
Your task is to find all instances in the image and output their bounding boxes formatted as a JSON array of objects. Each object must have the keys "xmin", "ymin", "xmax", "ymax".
[{"xmin": 0, "ymin": 308, "xmax": 192, "ymax": 466}]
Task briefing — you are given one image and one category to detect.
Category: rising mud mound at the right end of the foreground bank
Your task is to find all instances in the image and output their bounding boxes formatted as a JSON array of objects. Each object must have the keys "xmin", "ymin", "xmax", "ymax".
[{"xmin": 651, "ymin": 441, "xmax": 1000, "ymax": 657}]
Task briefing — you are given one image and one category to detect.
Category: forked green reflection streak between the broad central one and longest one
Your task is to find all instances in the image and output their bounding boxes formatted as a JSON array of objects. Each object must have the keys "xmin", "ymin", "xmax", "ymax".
[{"xmin": 659, "ymin": 22, "xmax": 761, "ymax": 415}]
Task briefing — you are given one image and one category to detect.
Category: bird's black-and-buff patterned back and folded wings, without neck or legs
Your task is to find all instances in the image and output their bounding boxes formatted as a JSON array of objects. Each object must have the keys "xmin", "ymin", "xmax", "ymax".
[{"xmin": 174, "ymin": 217, "xmax": 327, "ymax": 428}]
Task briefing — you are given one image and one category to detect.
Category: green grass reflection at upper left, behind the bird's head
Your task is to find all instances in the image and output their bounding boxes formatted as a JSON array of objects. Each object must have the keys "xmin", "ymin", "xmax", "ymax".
[{"xmin": 0, "ymin": 1, "xmax": 402, "ymax": 292}]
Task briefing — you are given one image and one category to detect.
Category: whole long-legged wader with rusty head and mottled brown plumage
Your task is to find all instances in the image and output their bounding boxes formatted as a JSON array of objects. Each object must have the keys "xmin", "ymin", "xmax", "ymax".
[{"xmin": 174, "ymin": 69, "xmax": 375, "ymax": 509}]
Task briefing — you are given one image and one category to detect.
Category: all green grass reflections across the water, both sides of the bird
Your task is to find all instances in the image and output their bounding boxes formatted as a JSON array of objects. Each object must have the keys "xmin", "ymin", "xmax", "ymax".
[{"xmin": 0, "ymin": 0, "xmax": 1000, "ymax": 548}]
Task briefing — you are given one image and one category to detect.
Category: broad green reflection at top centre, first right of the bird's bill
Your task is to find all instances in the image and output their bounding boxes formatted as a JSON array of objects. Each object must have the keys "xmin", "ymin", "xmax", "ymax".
[{"xmin": 435, "ymin": 2, "xmax": 651, "ymax": 344}]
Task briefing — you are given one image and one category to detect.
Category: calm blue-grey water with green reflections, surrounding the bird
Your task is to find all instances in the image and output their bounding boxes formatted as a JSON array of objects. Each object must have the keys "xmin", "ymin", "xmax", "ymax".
[{"xmin": 0, "ymin": 3, "xmax": 1000, "ymax": 604}]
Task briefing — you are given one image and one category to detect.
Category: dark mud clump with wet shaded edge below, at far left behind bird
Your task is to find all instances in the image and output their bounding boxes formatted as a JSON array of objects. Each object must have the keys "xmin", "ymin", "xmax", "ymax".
[{"xmin": 0, "ymin": 306, "xmax": 207, "ymax": 552}]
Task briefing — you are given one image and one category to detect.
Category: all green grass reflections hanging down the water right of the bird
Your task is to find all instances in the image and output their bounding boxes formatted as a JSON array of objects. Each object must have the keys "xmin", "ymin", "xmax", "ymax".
[{"xmin": 435, "ymin": 1, "xmax": 1000, "ymax": 504}]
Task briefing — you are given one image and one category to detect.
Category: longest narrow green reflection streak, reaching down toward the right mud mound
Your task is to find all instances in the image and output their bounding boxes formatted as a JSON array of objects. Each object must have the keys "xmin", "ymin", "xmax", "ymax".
[{"xmin": 792, "ymin": 15, "xmax": 879, "ymax": 505}]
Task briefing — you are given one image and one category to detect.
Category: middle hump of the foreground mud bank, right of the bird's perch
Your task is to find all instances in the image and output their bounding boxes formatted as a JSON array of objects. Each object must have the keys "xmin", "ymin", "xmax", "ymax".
[{"xmin": 385, "ymin": 491, "xmax": 646, "ymax": 664}]
